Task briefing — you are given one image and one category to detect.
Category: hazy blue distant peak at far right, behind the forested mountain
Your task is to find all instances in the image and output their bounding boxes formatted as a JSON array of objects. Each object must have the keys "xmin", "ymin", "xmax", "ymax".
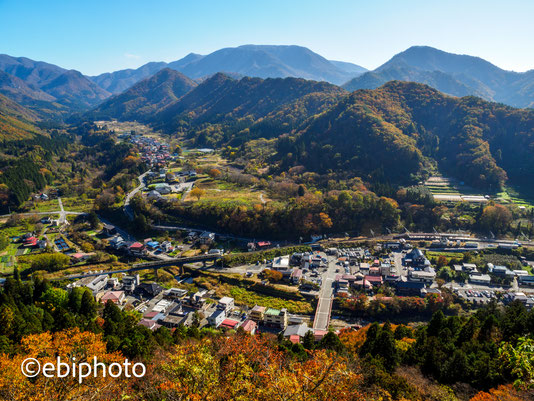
[{"xmin": 343, "ymin": 46, "xmax": 534, "ymax": 107}]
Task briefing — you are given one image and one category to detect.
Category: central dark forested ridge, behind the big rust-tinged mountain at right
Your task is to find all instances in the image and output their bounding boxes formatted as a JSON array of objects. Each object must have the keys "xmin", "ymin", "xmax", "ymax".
[{"xmin": 151, "ymin": 73, "xmax": 346, "ymax": 145}]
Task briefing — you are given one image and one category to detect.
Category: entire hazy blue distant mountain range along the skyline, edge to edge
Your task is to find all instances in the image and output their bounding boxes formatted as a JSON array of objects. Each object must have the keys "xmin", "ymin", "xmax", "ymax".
[{"xmin": 0, "ymin": 45, "xmax": 534, "ymax": 119}]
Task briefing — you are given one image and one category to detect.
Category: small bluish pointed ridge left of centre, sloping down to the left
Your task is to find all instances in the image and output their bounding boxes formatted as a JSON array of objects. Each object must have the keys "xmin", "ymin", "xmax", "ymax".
[{"xmin": 88, "ymin": 68, "xmax": 197, "ymax": 121}]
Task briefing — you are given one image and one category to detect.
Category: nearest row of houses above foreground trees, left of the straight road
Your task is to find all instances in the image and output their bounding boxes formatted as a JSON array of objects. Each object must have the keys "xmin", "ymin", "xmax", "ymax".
[{"xmin": 67, "ymin": 268, "xmax": 324, "ymax": 342}]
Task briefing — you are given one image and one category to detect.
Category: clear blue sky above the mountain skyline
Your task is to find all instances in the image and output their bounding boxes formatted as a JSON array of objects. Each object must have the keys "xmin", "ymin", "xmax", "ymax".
[{"xmin": 0, "ymin": 0, "xmax": 534, "ymax": 75}]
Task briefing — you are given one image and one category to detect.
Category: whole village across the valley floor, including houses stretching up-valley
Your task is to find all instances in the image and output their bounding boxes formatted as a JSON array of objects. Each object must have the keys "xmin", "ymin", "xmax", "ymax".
[{"xmin": 4, "ymin": 129, "xmax": 534, "ymax": 343}]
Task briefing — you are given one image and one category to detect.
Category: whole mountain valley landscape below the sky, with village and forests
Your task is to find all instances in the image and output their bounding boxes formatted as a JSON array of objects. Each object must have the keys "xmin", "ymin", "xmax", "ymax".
[{"xmin": 0, "ymin": 37, "xmax": 534, "ymax": 401}]
